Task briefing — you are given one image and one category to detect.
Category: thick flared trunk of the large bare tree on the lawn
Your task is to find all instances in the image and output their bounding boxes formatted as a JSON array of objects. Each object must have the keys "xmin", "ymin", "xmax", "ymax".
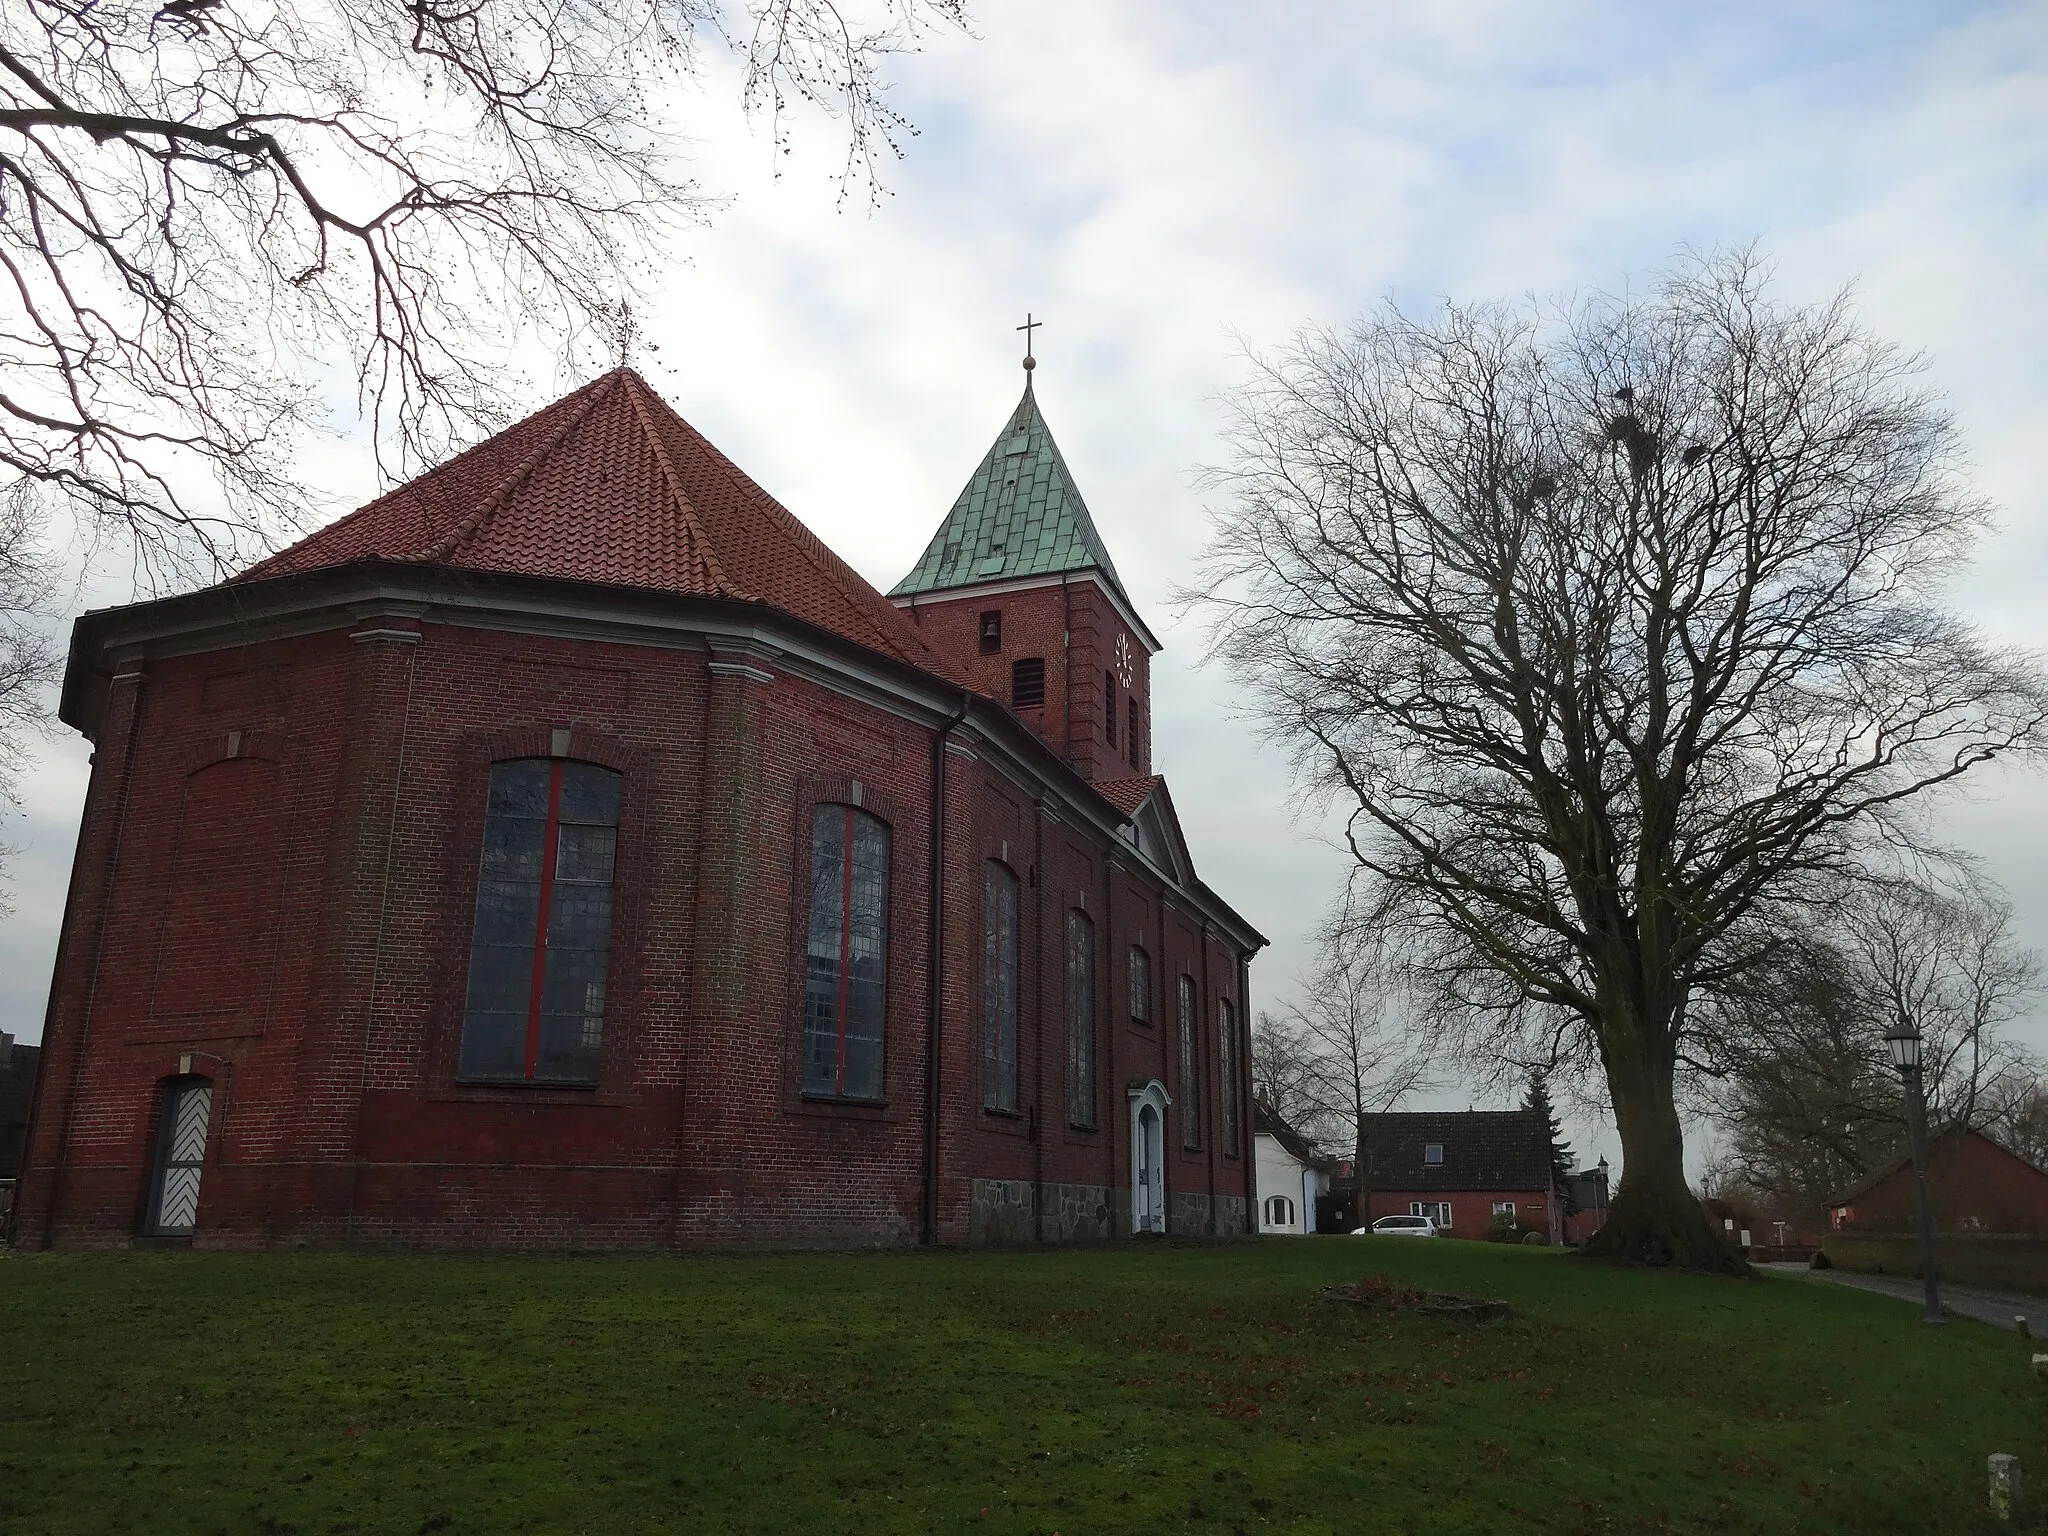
[{"xmin": 1581, "ymin": 1042, "xmax": 1749, "ymax": 1274}]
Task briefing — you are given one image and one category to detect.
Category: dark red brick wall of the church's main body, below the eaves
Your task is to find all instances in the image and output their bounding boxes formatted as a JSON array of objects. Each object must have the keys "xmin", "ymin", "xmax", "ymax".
[{"xmin": 16, "ymin": 593, "xmax": 1249, "ymax": 1247}]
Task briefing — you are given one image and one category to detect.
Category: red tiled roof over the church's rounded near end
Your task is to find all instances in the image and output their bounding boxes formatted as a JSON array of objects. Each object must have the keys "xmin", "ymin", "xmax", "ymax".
[{"xmin": 233, "ymin": 369, "xmax": 961, "ymax": 682}]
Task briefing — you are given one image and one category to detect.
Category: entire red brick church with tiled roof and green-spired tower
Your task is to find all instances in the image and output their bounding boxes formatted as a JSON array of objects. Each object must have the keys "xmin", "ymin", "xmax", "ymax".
[{"xmin": 14, "ymin": 371, "xmax": 1264, "ymax": 1249}]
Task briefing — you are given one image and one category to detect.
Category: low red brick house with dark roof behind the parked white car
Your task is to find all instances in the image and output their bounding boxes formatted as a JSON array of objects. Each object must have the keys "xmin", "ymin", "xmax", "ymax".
[{"xmin": 1354, "ymin": 1110, "xmax": 1565, "ymax": 1243}]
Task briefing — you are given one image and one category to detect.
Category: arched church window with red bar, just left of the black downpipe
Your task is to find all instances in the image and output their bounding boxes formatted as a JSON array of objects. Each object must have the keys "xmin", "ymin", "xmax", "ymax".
[{"xmin": 803, "ymin": 805, "xmax": 889, "ymax": 1100}]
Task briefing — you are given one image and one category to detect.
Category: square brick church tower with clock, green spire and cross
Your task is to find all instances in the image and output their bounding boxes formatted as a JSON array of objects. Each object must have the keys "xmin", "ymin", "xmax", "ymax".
[{"xmin": 889, "ymin": 352, "xmax": 1159, "ymax": 782}]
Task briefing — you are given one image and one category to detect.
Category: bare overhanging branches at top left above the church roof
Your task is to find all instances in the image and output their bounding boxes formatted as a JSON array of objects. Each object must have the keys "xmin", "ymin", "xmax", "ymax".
[{"xmin": 0, "ymin": 0, "xmax": 965, "ymax": 584}]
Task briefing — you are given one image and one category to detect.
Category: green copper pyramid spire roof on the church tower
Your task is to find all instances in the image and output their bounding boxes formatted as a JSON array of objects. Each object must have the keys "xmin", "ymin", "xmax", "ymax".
[{"xmin": 889, "ymin": 382, "xmax": 1130, "ymax": 606}]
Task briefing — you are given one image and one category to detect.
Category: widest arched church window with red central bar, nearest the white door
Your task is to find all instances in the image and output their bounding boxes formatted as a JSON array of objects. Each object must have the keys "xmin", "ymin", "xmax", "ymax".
[{"xmin": 459, "ymin": 758, "xmax": 618, "ymax": 1083}]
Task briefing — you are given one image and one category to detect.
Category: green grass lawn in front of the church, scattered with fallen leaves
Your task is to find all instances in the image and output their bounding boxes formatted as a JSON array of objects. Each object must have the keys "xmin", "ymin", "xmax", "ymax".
[{"xmin": 0, "ymin": 1237, "xmax": 2048, "ymax": 1536}]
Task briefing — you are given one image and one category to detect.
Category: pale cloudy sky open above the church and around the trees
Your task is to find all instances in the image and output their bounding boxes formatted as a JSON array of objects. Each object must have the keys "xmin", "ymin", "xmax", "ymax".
[{"xmin": 0, "ymin": 0, "xmax": 2048, "ymax": 1159}]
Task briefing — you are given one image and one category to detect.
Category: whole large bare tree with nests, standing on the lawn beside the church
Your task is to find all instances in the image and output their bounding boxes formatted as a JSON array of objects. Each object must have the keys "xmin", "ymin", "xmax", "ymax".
[{"xmin": 1196, "ymin": 252, "xmax": 2048, "ymax": 1268}]
